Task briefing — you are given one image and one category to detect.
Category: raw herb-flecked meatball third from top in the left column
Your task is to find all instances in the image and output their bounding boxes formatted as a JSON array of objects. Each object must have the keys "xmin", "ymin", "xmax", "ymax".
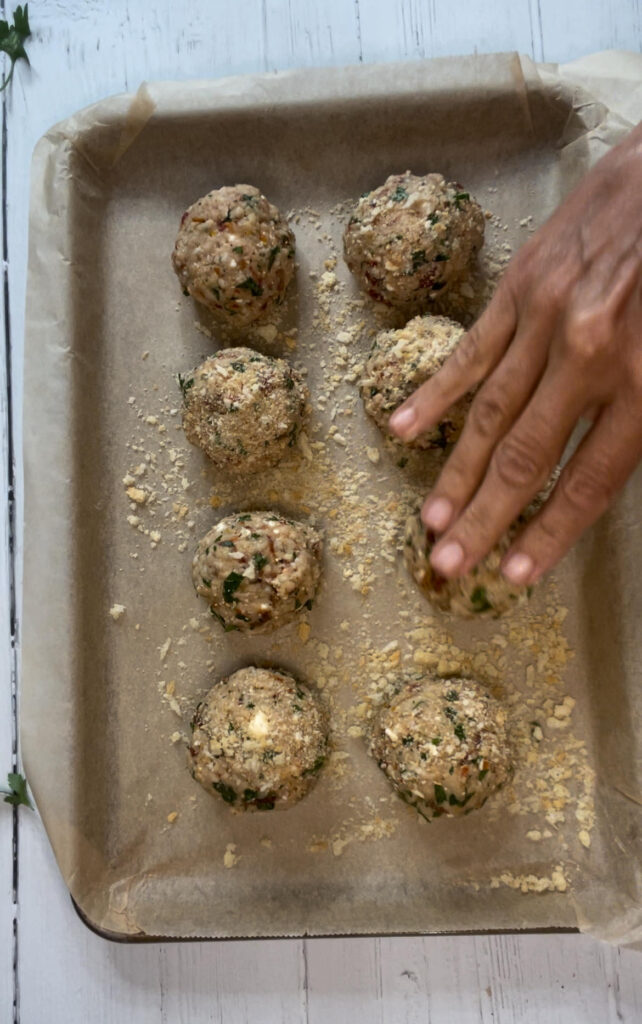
[{"xmin": 191, "ymin": 512, "xmax": 322, "ymax": 633}]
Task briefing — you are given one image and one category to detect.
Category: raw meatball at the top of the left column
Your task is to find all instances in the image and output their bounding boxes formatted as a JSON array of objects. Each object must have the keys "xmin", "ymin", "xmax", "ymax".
[{"xmin": 172, "ymin": 185, "xmax": 294, "ymax": 328}]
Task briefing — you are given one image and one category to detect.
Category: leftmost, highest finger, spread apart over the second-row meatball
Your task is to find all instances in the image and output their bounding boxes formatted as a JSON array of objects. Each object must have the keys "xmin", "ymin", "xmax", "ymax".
[{"xmin": 388, "ymin": 282, "xmax": 517, "ymax": 441}]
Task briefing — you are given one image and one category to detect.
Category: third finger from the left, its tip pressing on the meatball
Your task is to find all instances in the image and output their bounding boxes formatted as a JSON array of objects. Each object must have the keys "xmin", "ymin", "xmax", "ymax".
[{"xmin": 430, "ymin": 368, "xmax": 586, "ymax": 578}]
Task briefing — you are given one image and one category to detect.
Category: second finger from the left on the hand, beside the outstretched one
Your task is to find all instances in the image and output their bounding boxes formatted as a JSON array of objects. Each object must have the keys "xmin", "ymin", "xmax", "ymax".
[{"xmin": 422, "ymin": 323, "xmax": 548, "ymax": 534}]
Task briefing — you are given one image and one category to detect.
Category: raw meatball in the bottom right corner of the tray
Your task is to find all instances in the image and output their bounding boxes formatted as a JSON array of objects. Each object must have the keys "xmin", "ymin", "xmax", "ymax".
[{"xmin": 371, "ymin": 678, "xmax": 512, "ymax": 818}]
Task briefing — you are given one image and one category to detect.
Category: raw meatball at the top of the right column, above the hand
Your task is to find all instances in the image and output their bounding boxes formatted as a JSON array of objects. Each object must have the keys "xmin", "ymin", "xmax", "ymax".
[{"xmin": 343, "ymin": 171, "xmax": 484, "ymax": 308}]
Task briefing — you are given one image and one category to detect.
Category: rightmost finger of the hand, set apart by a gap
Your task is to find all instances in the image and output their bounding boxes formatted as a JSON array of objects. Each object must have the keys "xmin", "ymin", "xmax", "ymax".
[{"xmin": 502, "ymin": 400, "xmax": 642, "ymax": 585}]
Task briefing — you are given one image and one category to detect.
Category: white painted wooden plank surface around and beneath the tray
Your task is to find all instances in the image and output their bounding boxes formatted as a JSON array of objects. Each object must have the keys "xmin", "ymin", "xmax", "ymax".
[{"xmin": 0, "ymin": 0, "xmax": 642, "ymax": 1024}]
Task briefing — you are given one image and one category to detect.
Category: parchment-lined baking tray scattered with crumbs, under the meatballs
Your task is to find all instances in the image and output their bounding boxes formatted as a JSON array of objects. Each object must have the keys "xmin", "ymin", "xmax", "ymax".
[{"xmin": 22, "ymin": 54, "xmax": 642, "ymax": 939}]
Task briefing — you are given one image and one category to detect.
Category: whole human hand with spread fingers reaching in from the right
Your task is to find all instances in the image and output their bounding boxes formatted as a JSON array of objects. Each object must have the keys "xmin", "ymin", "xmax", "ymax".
[{"xmin": 389, "ymin": 125, "xmax": 642, "ymax": 585}]
